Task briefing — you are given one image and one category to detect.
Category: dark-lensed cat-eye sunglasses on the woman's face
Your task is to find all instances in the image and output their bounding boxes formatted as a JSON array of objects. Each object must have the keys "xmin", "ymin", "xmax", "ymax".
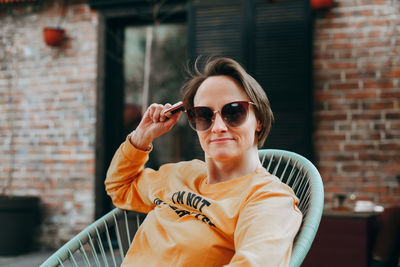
[{"xmin": 186, "ymin": 101, "xmax": 255, "ymax": 132}]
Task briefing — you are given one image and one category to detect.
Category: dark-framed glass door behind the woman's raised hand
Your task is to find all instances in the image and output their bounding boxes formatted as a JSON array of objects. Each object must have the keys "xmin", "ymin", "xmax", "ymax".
[{"xmin": 95, "ymin": 4, "xmax": 190, "ymax": 218}]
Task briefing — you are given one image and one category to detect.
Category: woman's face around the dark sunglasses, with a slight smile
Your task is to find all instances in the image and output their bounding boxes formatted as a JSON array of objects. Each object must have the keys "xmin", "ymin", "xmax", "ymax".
[{"xmin": 194, "ymin": 75, "xmax": 261, "ymax": 161}]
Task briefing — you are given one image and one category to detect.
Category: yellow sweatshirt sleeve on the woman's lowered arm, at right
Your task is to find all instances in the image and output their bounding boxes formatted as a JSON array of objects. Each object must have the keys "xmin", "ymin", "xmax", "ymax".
[{"xmin": 226, "ymin": 184, "xmax": 302, "ymax": 267}]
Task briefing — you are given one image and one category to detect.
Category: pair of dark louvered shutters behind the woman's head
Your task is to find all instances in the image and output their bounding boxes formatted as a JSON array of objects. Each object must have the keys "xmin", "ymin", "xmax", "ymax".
[{"xmin": 189, "ymin": 0, "xmax": 312, "ymax": 159}]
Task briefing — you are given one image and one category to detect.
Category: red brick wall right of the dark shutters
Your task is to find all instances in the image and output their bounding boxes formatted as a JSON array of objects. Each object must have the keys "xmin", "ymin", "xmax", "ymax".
[{"xmin": 314, "ymin": 0, "xmax": 400, "ymax": 209}]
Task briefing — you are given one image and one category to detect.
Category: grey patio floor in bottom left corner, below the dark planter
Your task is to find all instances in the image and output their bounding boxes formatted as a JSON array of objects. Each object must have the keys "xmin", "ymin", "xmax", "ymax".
[{"xmin": 0, "ymin": 251, "xmax": 53, "ymax": 267}]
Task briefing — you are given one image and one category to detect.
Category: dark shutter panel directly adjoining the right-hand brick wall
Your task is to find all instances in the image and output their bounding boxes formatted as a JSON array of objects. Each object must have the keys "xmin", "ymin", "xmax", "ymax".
[{"xmin": 254, "ymin": 0, "xmax": 312, "ymax": 159}]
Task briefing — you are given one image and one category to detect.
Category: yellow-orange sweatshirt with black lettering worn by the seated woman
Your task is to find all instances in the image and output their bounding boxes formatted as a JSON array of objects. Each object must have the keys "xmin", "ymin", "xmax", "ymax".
[{"xmin": 105, "ymin": 140, "xmax": 302, "ymax": 267}]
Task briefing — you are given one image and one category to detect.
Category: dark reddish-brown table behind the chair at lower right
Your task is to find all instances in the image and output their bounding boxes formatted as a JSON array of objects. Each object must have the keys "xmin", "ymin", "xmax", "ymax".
[{"xmin": 302, "ymin": 210, "xmax": 379, "ymax": 267}]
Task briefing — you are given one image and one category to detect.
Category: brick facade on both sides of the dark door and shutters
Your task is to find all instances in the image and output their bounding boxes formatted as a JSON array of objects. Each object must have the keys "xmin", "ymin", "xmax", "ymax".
[{"xmin": 0, "ymin": 0, "xmax": 400, "ymax": 251}]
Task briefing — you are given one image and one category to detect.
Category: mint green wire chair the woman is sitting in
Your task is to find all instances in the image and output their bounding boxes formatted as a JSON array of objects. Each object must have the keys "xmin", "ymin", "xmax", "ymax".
[{"xmin": 41, "ymin": 149, "xmax": 324, "ymax": 267}]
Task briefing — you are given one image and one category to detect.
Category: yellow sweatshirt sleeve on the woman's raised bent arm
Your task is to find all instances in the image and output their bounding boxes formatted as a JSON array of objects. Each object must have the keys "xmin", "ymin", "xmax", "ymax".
[{"xmin": 105, "ymin": 137, "xmax": 160, "ymax": 213}]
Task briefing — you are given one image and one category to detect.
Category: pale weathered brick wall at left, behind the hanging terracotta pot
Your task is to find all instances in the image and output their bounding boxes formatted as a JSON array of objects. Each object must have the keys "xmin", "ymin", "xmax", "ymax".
[{"xmin": 0, "ymin": 1, "xmax": 97, "ymax": 248}]
